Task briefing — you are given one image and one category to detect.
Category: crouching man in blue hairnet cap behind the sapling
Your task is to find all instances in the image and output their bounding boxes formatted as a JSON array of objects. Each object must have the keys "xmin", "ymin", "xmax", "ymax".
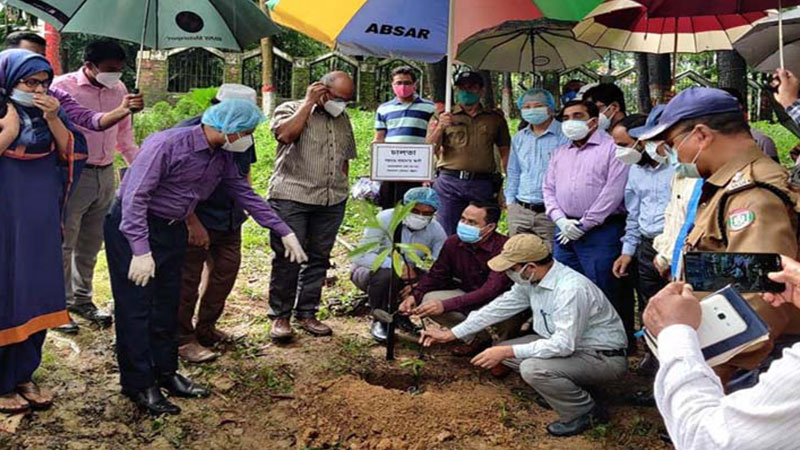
[{"xmin": 350, "ymin": 187, "xmax": 447, "ymax": 343}]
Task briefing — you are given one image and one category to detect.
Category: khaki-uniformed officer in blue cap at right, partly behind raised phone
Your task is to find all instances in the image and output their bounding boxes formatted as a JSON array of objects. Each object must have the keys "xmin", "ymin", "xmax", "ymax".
[{"xmin": 641, "ymin": 88, "xmax": 800, "ymax": 383}]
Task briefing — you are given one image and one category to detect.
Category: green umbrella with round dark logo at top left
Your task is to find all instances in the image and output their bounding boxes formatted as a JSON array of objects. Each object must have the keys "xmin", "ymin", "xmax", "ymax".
[{"xmin": 2, "ymin": 0, "xmax": 280, "ymax": 82}]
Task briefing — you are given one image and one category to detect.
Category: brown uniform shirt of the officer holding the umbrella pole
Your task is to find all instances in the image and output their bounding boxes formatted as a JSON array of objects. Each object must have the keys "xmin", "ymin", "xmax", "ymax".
[{"xmin": 428, "ymin": 106, "xmax": 511, "ymax": 173}]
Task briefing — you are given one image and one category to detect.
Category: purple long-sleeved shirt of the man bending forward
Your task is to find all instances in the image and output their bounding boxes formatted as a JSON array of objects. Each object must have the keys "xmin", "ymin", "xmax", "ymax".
[{"xmin": 119, "ymin": 125, "xmax": 293, "ymax": 255}]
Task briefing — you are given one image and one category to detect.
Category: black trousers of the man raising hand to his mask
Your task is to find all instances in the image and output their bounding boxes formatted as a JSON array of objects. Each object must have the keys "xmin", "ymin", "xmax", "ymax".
[{"xmin": 269, "ymin": 199, "xmax": 346, "ymax": 319}]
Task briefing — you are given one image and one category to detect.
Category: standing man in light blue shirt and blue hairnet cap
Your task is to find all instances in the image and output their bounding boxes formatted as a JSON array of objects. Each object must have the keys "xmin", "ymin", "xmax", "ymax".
[{"xmin": 505, "ymin": 89, "xmax": 569, "ymax": 243}]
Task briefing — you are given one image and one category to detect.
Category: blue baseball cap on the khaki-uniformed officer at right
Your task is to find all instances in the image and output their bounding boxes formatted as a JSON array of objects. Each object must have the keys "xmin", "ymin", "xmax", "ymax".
[{"xmin": 631, "ymin": 87, "xmax": 742, "ymax": 141}]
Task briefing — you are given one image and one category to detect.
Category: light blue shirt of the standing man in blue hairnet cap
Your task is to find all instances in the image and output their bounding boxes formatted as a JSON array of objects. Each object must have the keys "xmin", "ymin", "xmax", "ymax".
[{"xmin": 505, "ymin": 120, "xmax": 569, "ymax": 204}]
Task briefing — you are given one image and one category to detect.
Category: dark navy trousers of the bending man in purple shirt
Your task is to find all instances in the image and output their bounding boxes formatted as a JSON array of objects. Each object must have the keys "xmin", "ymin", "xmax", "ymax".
[{"xmin": 103, "ymin": 199, "xmax": 188, "ymax": 391}]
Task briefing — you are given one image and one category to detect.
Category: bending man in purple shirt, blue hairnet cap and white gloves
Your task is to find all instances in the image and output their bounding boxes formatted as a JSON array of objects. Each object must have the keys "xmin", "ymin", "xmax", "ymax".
[{"xmin": 104, "ymin": 99, "xmax": 307, "ymax": 414}]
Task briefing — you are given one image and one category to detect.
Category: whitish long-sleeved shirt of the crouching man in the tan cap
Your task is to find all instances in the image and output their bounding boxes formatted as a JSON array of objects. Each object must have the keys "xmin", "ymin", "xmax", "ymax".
[{"xmin": 452, "ymin": 262, "xmax": 628, "ymax": 359}]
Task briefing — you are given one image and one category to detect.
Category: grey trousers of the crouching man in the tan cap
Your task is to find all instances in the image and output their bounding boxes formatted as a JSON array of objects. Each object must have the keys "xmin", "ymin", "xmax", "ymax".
[{"xmin": 497, "ymin": 335, "xmax": 628, "ymax": 422}]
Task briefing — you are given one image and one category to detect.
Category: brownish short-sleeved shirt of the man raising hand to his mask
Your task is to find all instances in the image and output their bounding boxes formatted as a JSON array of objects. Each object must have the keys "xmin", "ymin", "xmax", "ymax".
[{"xmin": 269, "ymin": 101, "xmax": 357, "ymax": 206}]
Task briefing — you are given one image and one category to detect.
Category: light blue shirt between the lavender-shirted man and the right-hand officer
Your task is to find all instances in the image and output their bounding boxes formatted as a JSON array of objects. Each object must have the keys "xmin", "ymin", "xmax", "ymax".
[{"xmin": 622, "ymin": 164, "xmax": 675, "ymax": 255}]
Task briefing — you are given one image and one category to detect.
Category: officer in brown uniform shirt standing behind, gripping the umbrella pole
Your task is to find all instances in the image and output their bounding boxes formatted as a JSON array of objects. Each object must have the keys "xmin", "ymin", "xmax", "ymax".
[{"xmin": 426, "ymin": 72, "xmax": 511, "ymax": 235}]
